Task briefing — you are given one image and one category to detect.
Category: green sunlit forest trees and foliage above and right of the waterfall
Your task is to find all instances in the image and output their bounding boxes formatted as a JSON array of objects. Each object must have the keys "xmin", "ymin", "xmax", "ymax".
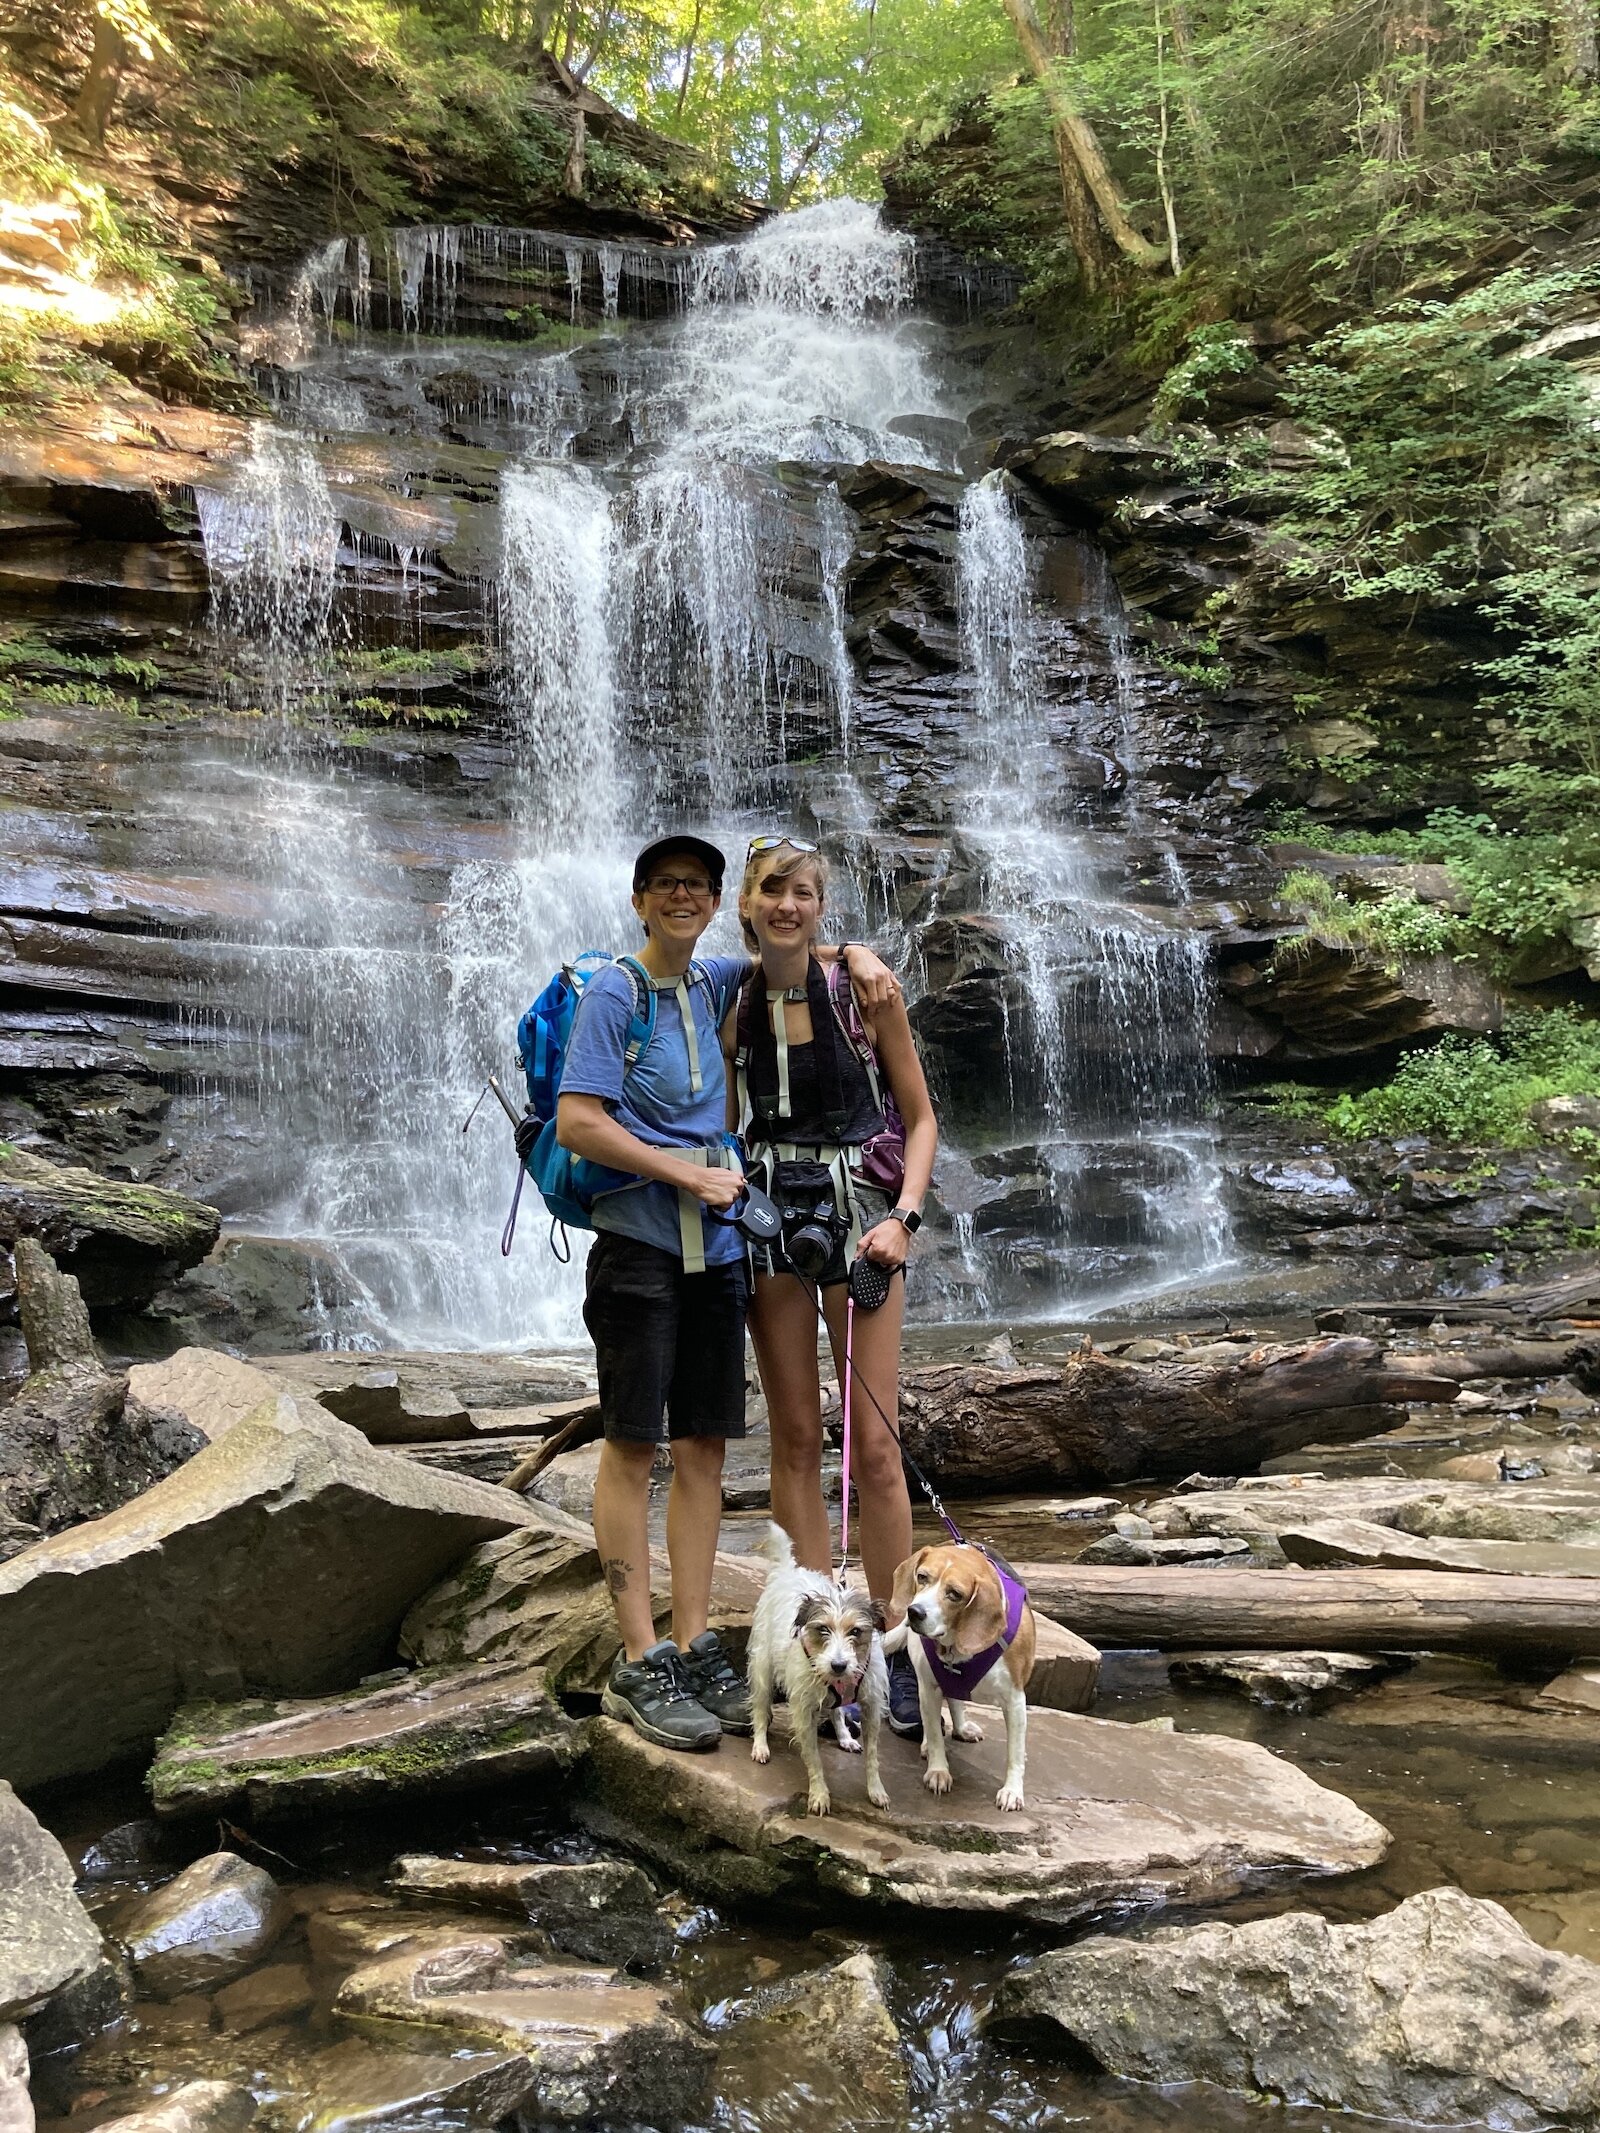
[{"xmin": 0, "ymin": 0, "xmax": 1600, "ymax": 1160}]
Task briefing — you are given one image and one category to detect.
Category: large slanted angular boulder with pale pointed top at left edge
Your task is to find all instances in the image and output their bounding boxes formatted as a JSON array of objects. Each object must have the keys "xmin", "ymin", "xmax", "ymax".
[{"xmin": 0, "ymin": 1395, "xmax": 535, "ymax": 1785}]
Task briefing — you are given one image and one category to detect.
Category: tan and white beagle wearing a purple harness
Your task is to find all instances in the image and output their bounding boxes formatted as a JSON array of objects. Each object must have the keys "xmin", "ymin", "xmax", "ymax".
[{"xmin": 883, "ymin": 1544, "xmax": 1035, "ymax": 1813}]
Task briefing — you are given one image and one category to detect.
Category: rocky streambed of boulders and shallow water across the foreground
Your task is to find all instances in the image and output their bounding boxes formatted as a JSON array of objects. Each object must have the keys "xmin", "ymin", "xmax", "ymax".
[{"xmin": 0, "ymin": 1252, "xmax": 1600, "ymax": 2133}]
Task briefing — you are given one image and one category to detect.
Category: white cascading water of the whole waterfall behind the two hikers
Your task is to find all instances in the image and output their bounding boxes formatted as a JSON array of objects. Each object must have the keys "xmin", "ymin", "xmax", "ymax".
[{"xmin": 190, "ymin": 201, "xmax": 1216, "ymax": 1346}]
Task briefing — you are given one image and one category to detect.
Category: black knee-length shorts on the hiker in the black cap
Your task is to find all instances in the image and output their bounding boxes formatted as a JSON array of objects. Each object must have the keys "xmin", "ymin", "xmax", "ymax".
[{"xmin": 582, "ymin": 1229, "xmax": 751, "ymax": 1444}]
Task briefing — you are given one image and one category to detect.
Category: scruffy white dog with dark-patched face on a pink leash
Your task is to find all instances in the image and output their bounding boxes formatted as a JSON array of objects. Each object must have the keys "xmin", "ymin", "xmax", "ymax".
[{"xmin": 749, "ymin": 1525, "xmax": 890, "ymax": 1815}]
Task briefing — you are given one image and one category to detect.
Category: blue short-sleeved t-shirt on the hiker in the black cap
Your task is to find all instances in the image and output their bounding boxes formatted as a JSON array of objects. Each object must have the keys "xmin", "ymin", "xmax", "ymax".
[{"xmin": 561, "ymin": 956, "xmax": 751, "ymax": 1267}]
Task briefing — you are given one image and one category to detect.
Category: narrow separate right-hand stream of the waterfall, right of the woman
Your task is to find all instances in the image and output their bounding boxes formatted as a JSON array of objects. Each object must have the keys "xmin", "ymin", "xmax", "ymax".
[{"xmin": 958, "ymin": 471, "xmax": 1229, "ymax": 1310}]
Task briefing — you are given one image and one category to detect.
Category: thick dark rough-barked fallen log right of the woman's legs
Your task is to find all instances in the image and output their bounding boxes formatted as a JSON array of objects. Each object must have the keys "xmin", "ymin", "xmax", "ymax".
[{"xmin": 900, "ymin": 1337, "xmax": 1457, "ymax": 1493}]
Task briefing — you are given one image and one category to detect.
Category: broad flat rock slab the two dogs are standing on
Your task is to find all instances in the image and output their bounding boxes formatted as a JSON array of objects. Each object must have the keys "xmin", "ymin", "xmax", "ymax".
[{"xmin": 574, "ymin": 1711, "xmax": 1389, "ymax": 1924}]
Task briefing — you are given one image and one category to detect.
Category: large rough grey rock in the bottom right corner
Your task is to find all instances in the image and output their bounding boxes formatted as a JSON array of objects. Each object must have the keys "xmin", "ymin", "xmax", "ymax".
[{"xmin": 996, "ymin": 1888, "xmax": 1600, "ymax": 2129}]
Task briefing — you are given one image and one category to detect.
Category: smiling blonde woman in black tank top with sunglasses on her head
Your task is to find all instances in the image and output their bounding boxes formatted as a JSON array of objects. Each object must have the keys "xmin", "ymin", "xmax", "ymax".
[{"xmin": 723, "ymin": 840, "xmax": 939, "ymax": 1732}]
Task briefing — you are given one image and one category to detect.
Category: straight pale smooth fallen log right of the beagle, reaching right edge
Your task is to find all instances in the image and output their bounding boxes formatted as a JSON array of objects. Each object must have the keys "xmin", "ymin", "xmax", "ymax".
[{"xmin": 1018, "ymin": 1563, "xmax": 1600, "ymax": 1657}]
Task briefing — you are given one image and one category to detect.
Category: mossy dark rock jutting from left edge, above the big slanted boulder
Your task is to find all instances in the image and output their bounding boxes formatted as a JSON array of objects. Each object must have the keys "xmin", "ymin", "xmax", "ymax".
[{"xmin": 0, "ymin": 1141, "xmax": 222, "ymax": 1310}]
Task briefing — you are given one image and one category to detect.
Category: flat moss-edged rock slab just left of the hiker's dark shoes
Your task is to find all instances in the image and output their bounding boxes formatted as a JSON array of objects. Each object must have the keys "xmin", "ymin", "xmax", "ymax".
[{"xmin": 147, "ymin": 1659, "xmax": 582, "ymax": 1817}]
